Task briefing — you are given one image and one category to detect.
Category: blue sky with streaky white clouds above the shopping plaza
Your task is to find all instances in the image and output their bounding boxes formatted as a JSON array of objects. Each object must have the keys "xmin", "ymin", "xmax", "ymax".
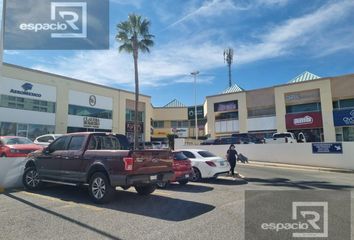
[{"xmin": 0, "ymin": 0, "xmax": 354, "ymax": 106}]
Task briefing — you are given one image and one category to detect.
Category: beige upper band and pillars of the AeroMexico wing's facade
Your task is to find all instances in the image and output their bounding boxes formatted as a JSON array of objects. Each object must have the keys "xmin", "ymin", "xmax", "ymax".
[{"xmin": 3, "ymin": 65, "xmax": 152, "ymax": 142}]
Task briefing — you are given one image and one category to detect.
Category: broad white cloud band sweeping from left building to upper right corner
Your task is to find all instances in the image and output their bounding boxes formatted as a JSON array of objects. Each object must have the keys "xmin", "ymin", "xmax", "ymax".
[{"xmin": 27, "ymin": 1, "xmax": 354, "ymax": 87}]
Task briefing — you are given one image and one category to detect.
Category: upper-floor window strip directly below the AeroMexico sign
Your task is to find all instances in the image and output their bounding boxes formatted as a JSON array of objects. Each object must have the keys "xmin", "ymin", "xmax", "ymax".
[{"xmin": 0, "ymin": 95, "xmax": 55, "ymax": 113}]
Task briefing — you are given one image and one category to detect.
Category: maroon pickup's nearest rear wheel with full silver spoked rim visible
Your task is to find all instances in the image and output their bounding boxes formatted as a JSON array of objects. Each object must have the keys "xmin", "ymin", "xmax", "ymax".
[{"xmin": 89, "ymin": 172, "xmax": 114, "ymax": 203}]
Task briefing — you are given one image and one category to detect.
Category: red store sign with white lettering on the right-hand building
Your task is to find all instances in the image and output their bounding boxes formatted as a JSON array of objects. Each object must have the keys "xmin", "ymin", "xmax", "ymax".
[{"xmin": 285, "ymin": 112, "xmax": 323, "ymax": 129}]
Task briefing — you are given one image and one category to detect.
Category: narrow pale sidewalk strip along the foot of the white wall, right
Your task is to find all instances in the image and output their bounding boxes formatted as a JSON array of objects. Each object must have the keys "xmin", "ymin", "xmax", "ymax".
[{"xmin": 249, "ymin": 161, "xmax": 354, "ymax": 174}]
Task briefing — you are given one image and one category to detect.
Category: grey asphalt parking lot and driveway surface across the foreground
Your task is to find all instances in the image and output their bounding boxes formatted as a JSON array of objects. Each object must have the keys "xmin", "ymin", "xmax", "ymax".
[{"xmin": 0, "ymin": 165, "xmax": 354, "ymax": 240}]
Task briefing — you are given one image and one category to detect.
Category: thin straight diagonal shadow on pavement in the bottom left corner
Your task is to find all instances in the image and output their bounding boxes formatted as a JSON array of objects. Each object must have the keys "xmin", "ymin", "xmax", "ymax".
[{"xmin": 4, "ymin": 193, "xmax": 120, "ymax": 240}]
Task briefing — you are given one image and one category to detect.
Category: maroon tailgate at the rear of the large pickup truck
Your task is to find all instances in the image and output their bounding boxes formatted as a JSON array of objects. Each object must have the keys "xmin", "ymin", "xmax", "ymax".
[{"xmin": 131, "ymin": 150, "xmax": 173, "ymax": 174}]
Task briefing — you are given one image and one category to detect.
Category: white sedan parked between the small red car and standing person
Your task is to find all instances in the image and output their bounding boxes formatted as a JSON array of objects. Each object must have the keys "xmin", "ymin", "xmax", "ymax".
[{"xmin": 178, "ymin": 149, "xmax": 230, "ymax": 181}]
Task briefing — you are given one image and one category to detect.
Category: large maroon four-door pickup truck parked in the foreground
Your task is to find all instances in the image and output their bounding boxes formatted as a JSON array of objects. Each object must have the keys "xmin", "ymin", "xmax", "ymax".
[{"xmin": 23, "ymin": 132, "xmax": 173, "ymax": 203}]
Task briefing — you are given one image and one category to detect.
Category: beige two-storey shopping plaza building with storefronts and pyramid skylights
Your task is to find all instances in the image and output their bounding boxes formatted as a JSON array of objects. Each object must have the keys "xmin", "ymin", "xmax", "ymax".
[{"xmin": 0, "ymin": 64, "xmax": 354, "ymax": 142}]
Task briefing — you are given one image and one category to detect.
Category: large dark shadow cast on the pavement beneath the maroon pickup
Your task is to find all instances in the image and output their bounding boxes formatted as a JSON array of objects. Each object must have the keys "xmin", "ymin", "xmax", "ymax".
[{"xmin": 10, "ymin": 186, "xmax": 215, "ymax": 221}]
